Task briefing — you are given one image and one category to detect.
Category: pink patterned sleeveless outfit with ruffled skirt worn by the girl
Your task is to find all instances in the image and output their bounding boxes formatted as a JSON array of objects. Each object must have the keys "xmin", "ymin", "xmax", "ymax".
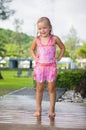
[{"xmin": 34, "ymin": 36, "xmax": 57, "ymax": 82}]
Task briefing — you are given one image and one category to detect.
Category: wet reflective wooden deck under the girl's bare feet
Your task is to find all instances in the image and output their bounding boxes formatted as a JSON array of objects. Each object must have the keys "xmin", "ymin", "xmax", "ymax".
[{"xmin": 0, "ymin": 95, "xmax": 86, "ymax": 130}]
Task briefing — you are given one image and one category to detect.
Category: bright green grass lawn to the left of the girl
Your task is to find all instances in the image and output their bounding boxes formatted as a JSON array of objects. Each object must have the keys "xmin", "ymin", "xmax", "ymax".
[{"xmin": 0, "ymin": 70, "xmax": 34, "ymax": 95}]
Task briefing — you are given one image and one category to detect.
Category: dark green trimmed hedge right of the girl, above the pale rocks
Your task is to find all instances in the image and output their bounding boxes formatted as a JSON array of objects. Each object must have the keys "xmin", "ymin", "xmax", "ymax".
[{"xmin": 56, "ymin": 70, "xmax": 84, "ymax": 89}]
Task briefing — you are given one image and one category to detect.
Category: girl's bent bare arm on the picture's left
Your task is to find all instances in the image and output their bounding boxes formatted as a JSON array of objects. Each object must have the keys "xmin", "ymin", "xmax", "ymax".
[{"xmin": 30, "ymin": 38, "xmax": 37, "ymax": 61}]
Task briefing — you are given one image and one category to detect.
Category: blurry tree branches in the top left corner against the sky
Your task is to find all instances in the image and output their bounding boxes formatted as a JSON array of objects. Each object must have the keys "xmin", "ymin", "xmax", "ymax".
[{"xmin": 0, "ymin": 0, "xmax": 15, "ymax": 20}]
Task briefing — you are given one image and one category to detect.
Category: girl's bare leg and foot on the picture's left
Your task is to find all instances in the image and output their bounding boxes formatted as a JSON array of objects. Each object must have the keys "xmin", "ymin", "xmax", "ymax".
[{"xmin": 34, "ymin": 82, "xmax": 44, "ymax": 117}]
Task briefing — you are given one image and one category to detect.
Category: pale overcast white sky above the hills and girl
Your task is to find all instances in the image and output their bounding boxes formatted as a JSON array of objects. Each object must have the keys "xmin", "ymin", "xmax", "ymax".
[{"xmin": 0, "ymin": 0, "xmax": 86, "ymax": 40}]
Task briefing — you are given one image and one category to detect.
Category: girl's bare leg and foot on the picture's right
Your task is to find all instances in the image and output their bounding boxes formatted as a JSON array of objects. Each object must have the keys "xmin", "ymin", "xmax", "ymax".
[{"xmin": 48, "ymin": 80, "xmax": 56, "ymax": 117}]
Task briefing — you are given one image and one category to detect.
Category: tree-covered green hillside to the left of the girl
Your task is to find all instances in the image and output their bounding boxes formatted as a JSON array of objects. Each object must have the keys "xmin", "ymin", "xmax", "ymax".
[{"xmin": 0, "ymin": 28, "xmax": 34, "ymax": 58}]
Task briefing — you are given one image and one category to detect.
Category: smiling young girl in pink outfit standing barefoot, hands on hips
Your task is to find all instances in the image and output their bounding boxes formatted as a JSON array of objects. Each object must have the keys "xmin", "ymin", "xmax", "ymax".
[{"xmin": 30, "ymin": 17, "xmax": 65, "ymax": 117}]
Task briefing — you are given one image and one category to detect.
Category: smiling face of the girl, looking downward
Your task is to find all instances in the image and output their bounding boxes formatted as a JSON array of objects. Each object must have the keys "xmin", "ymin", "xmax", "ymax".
[{"xmin": 37, "ymin": 21, "xmax": 51, "ymax": 37}]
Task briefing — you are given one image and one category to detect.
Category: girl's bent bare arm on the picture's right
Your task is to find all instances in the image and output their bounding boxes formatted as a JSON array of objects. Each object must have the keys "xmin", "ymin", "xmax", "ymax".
[{"xmin": 55, "ymin": 36, "xmax": 65, "ymax": 61}]
